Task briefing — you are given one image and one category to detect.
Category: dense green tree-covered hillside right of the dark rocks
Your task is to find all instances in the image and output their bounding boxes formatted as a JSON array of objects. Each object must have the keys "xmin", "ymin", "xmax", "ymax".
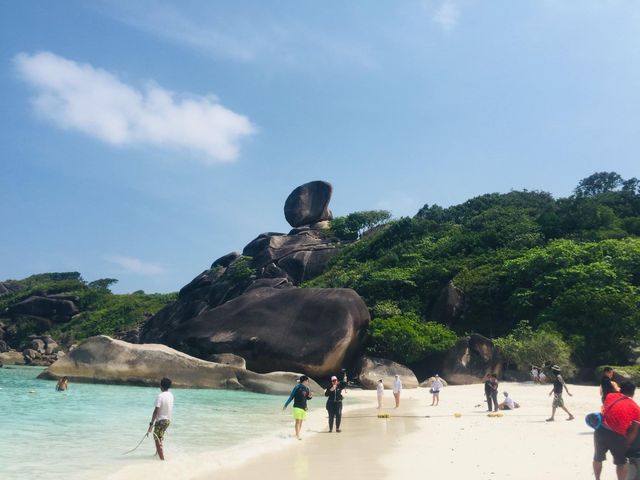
[{"xmin": 305, "ymin": 172, "xmax": 640, "ymax": 369}]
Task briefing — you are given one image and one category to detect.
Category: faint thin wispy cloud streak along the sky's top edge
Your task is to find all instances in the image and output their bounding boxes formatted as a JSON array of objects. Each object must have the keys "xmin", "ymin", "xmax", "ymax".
[{"xmin": 97, "ymin": 0, "xmax": 378, "ymax": 69}]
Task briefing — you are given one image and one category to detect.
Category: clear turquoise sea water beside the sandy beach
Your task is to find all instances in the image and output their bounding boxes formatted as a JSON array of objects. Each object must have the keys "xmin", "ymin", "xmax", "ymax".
[{"xmin": 0, "ymin": 367, "xmax": 308, "ymax": 480}]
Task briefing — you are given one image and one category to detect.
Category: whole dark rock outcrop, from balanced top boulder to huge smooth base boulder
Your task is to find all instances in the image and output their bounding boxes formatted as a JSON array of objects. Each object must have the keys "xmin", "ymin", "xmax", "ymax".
[{"xmin": 140, "ymin": 182, "xmax": 369, "ymax": 377}]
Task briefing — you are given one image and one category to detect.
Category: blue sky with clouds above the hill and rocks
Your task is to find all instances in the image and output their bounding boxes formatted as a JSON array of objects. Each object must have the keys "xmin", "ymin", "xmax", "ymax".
[{"xmin": 0, "ymin": 0, "xmax": 640, "ymax": 293}]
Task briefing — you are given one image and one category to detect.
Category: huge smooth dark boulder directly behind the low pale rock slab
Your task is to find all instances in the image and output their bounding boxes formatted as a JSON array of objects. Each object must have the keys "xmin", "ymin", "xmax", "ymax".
[{"xmin": 142, "ymin": 287, "xmax": 369, "ymax": 377}]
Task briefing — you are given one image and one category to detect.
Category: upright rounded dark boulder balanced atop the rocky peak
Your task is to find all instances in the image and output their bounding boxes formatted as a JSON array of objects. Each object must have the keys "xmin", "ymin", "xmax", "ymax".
[{"xmin": 284, "ymin": 181, "xmax": 333, "ymax": 228}]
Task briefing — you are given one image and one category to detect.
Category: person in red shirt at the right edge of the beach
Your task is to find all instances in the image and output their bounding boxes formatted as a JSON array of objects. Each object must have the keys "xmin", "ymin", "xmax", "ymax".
[{"xmin": 593, "ymin": 382, "xmax": 640, "ymax": 480}]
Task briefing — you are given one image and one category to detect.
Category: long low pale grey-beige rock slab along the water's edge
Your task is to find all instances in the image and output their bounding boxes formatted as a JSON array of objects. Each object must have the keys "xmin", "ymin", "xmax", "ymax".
[{"xmin": 38, "ymin": 335, "xmax": 323, "ymax": 395}]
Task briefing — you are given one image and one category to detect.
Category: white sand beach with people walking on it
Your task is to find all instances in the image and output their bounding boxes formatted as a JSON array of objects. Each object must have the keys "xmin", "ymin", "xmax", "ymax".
[{"xmin": 112, "ymin": 383, "xmax": 615, "ymax": 480}]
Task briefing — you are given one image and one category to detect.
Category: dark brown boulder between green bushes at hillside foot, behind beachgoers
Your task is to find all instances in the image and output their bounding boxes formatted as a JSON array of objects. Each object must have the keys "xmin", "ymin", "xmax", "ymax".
[{"xmin": 442, "ymin": 334, "xmax": 502, "ymax": 385}]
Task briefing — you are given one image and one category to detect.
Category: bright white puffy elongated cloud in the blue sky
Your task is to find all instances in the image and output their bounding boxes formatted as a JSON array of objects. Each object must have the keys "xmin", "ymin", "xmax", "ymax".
[{"xmin": 14, "ymin": 52, "xmax": 255, "ymax": 163}]
